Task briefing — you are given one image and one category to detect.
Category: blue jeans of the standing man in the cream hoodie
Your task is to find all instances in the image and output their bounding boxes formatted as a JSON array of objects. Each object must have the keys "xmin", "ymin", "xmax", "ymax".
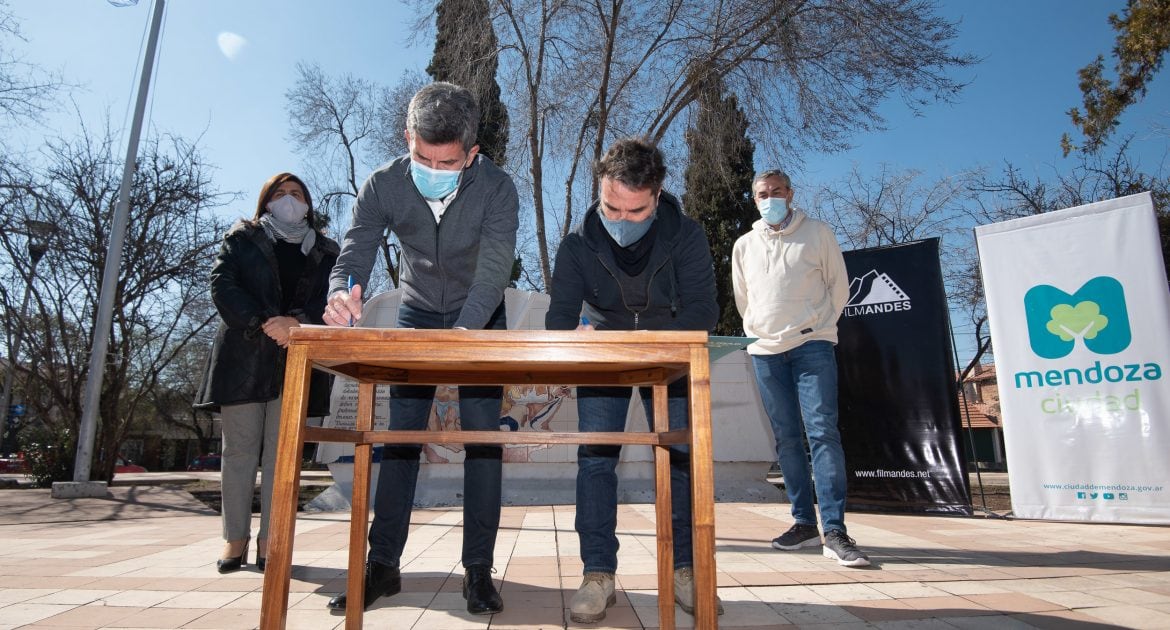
[{"xmin": 751, "ymin": 340, "xmax": 845, "ymax": 532}]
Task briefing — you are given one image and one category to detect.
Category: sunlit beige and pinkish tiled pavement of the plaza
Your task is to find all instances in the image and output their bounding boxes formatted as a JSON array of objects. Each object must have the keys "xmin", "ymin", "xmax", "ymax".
[{"xmin": 0, "ymin": 486, "xmax": 1170, "ymax": 630}]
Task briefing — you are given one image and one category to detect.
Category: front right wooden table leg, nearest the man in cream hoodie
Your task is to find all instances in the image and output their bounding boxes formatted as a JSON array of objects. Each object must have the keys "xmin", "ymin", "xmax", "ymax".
[{"xmin": 689, "ymin": 348, "xmax": 718, "ymax": 630}]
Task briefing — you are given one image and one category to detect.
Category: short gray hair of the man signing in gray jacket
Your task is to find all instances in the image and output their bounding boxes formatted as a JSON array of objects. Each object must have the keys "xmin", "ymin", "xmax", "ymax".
[{"xmin": 406, "ymin": 81, "xmax": 480, "ymax": 151}]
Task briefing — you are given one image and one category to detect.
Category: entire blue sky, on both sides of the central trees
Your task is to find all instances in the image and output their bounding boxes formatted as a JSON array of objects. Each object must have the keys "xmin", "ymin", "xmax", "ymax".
[{"xmin": 9, "ymin": 0, "xmax": 1170, "ymax": 363}]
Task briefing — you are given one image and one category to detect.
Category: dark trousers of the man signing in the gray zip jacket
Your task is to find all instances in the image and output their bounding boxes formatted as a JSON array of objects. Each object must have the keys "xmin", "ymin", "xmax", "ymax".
[{"xmin": 370, "ymin": 303, "xmax": 505, "ymax": 567}]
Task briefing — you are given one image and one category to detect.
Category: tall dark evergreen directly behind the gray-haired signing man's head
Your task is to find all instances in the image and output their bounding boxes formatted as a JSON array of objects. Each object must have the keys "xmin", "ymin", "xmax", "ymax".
[{"xmin": 427, "ymin": 0, "xmax": 508, "ymax": 166}]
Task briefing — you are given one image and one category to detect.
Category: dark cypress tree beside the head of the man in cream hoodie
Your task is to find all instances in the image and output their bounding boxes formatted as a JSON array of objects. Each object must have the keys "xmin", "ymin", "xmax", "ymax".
[{"xmin": 682, "ymin": 81, "xmax": 759, "ymax": 335}]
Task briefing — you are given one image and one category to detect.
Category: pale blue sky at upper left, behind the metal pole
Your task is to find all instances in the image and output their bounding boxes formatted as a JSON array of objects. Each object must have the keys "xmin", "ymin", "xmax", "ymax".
[{"xmin": 11, "ymin": 0, "xmax": 431, "ymax": 209}]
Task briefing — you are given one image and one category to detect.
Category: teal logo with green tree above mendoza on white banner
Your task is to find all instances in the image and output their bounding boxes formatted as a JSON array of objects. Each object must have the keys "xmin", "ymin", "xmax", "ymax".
[{"xmin": 1024, "ymin": 275, "xmax": 1131, "ymax": 358}]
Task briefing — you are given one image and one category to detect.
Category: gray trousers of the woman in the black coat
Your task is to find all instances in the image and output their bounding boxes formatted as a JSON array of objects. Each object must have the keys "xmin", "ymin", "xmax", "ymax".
[{"xmin": 220, "ymin": 398, "xmax": 281, "ymax": 541}]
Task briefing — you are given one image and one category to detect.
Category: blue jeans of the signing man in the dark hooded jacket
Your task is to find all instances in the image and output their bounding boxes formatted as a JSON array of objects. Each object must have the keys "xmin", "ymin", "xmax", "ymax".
[{"xmin": 576, "ymin": 388, "xmax": 693, "ymax": 573}]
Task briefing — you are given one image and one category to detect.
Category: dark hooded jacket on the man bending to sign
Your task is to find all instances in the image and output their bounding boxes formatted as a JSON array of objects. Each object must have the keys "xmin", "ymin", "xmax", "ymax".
[{"xmin": 544, "ymin": 192, "xmax": 718, "ymax": 331}]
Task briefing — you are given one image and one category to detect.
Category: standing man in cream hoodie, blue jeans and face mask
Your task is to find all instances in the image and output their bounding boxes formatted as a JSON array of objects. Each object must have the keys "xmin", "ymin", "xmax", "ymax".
[{"xmin": 731, "ymin": 171, "xmax": 869, "ymax": 567}]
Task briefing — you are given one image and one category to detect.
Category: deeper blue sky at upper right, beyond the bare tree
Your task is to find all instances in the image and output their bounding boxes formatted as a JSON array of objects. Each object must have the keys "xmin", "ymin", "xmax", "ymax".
[{"xmin": 805, "ymin": 0, "xmax": 1170, "ymax": 182}]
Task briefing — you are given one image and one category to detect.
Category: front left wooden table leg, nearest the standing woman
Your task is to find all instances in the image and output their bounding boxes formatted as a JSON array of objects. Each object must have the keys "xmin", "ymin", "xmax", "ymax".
[{"xmin": 260, "ymin": 343, "xmax": 312, "ymax": 630}]
